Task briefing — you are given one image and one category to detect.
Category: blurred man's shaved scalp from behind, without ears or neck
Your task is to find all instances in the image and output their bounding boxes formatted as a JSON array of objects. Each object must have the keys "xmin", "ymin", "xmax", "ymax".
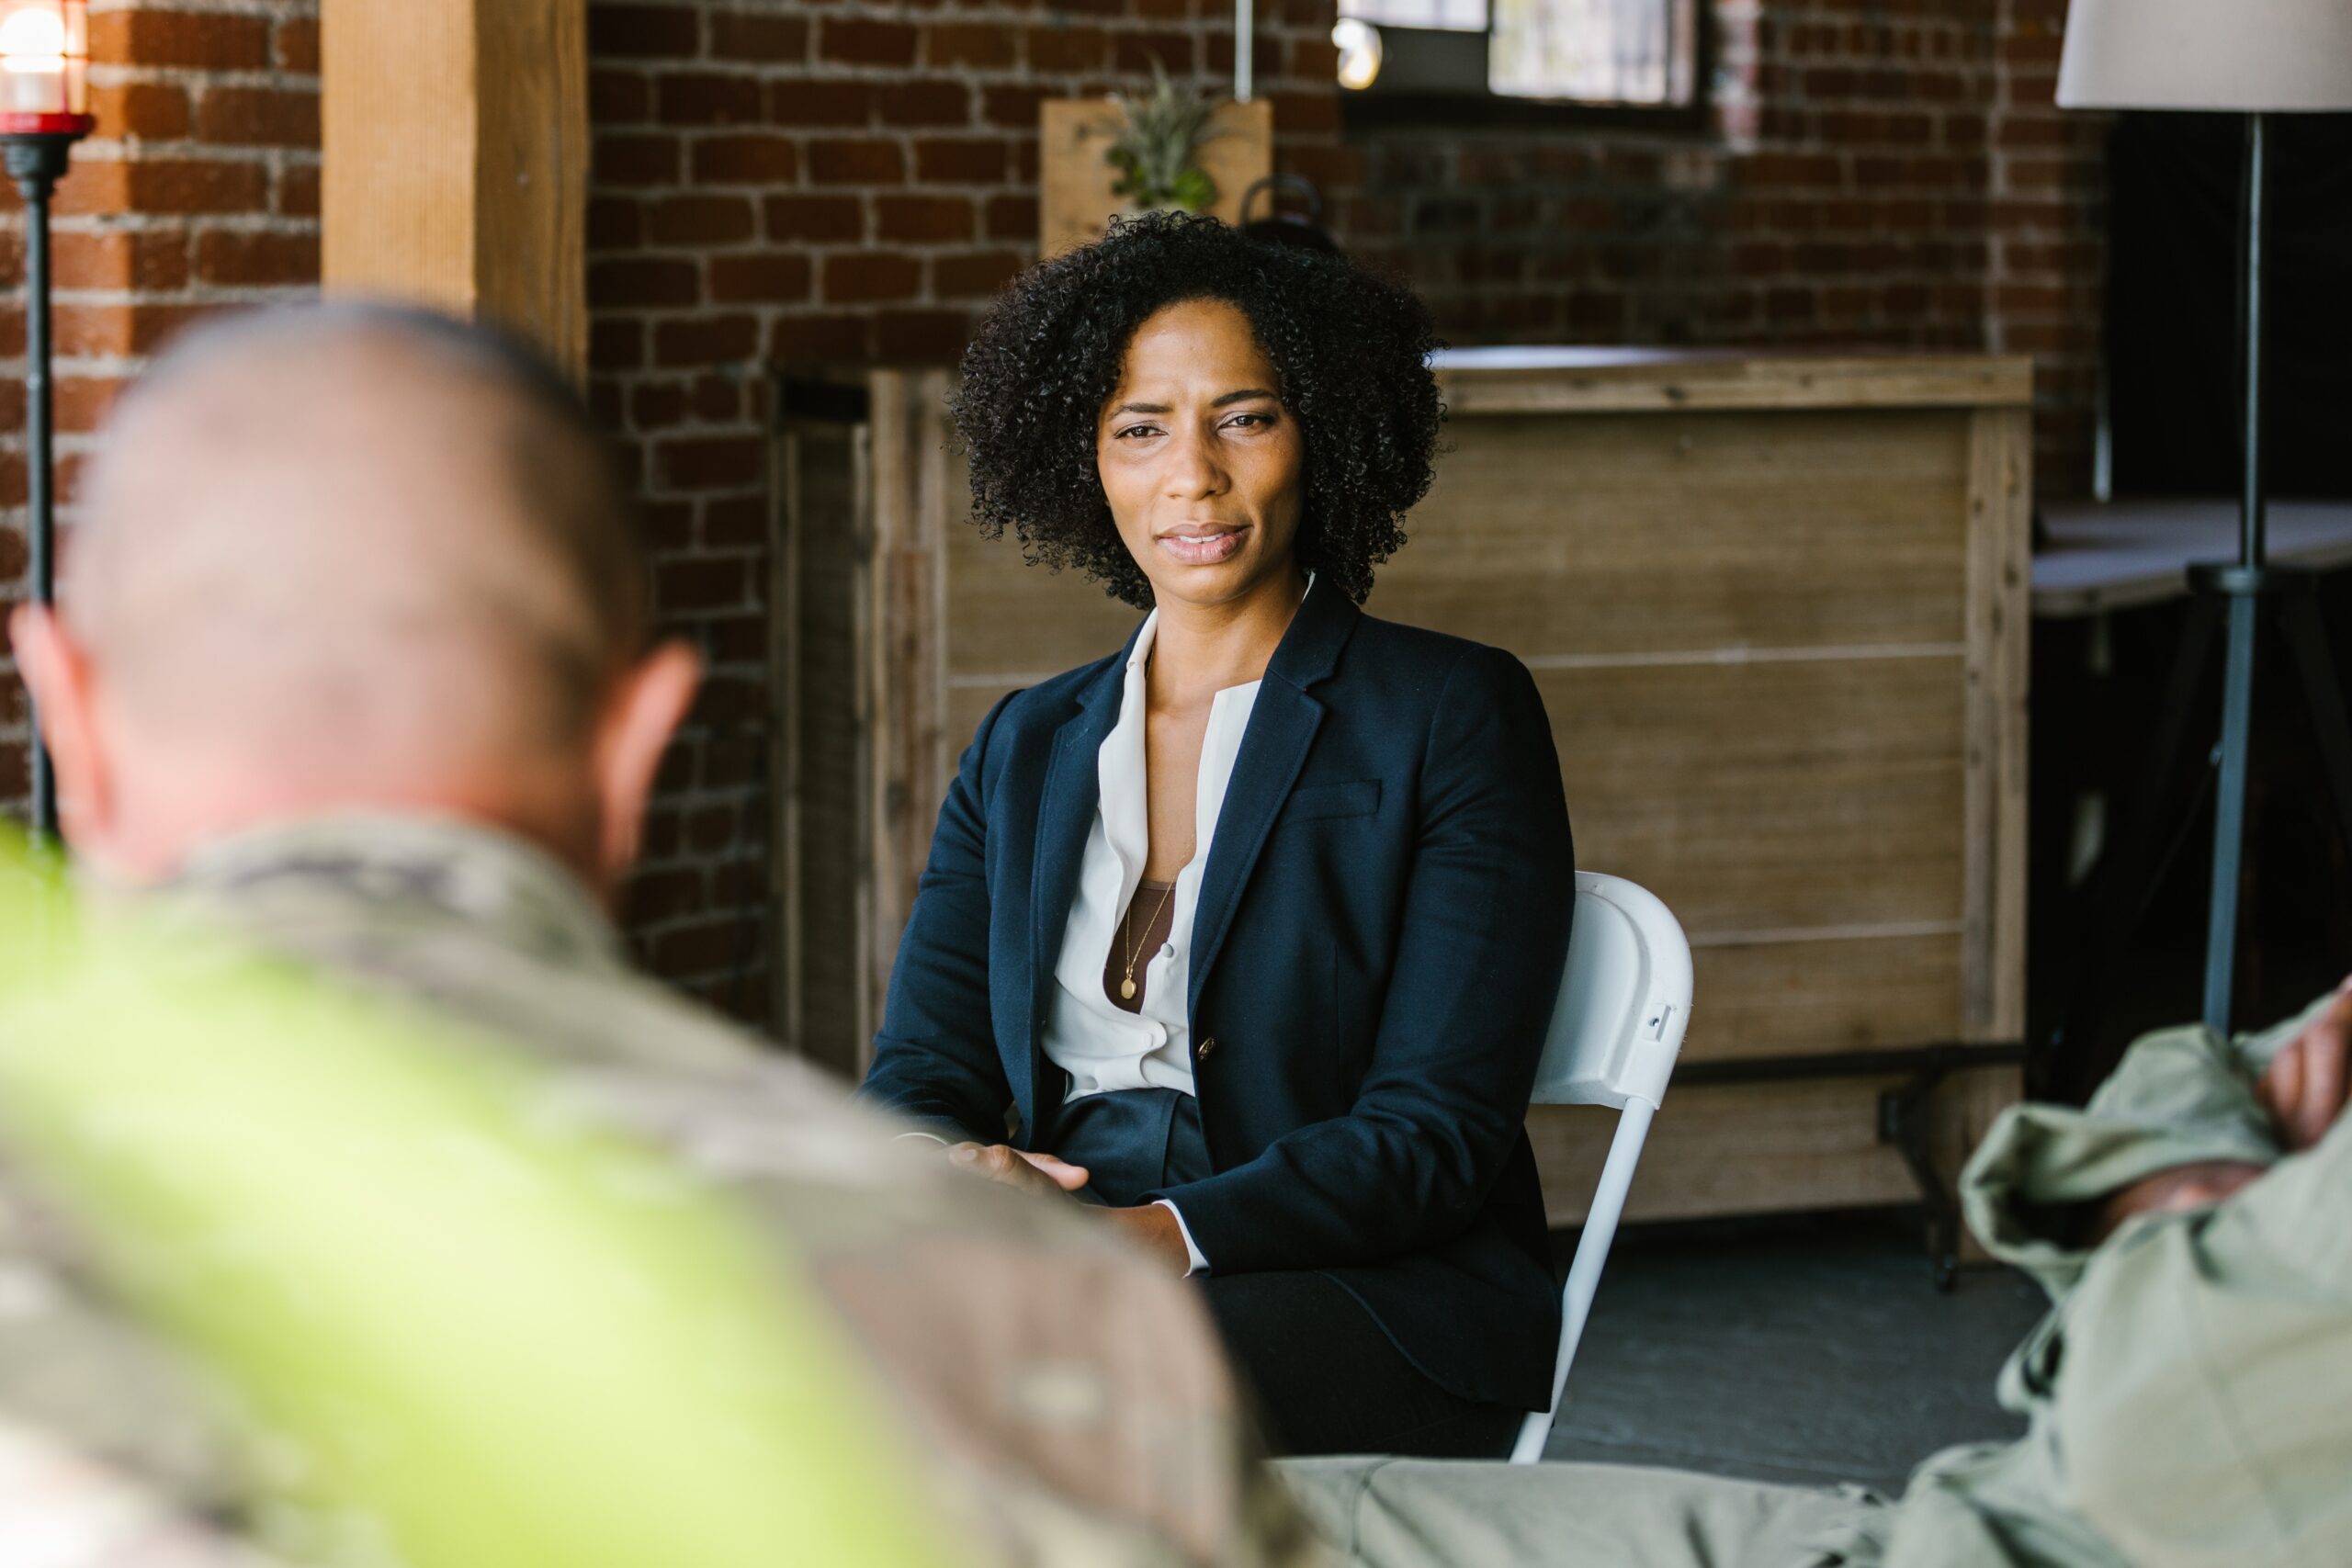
[{"xmin": 63, "ymin": 308, "xmax": 644, "ymax": 766}]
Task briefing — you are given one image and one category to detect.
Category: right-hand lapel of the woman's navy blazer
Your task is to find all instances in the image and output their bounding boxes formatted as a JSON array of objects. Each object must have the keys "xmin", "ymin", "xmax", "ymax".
[{"xmin": 1185, "ymin": 583, "xmax": 1364, "ymax": 1013}]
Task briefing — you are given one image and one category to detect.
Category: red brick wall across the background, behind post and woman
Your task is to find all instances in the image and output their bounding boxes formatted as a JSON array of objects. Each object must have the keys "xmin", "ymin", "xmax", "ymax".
[{"xmin": 0, "ymin": 0, "xmax": 2100, "ymax": 1013}]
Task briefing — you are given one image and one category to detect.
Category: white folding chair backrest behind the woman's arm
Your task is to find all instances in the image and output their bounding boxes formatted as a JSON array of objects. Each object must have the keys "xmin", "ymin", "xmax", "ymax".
[{"xmin": 1536, "ymin": 872, "xmax": 1691, "ymax": 1110}]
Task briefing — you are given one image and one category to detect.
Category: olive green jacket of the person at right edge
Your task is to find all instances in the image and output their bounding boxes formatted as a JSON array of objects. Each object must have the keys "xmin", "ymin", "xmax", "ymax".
[{"xmin": 1844, "ymin": 999, "xmax": 2352, "ymax": 1568}]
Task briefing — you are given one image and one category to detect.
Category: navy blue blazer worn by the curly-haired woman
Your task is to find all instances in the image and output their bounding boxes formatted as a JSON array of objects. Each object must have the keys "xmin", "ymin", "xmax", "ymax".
[{"xmin": 864, "ymin": 592, "xmax": 1574, "ymax": 1411}]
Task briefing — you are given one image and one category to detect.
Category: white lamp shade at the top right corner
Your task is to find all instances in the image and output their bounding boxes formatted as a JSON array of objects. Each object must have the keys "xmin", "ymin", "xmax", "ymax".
[{"xmin": 2058, "ymin": 0, "xmax": 2352, "ymax": 113}]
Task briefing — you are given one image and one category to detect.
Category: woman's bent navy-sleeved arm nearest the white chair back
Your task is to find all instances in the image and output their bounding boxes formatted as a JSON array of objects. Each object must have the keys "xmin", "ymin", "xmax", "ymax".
[{"xmin": 1150, "ymin": 649, "xmax": 1576, "ymax": 1272}]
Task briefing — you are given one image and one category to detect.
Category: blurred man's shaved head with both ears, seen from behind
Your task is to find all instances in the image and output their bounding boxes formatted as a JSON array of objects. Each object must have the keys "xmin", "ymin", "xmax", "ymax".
[{"xmin": 12, "ymin": 306, "xmax": 696, "ymax": 902}]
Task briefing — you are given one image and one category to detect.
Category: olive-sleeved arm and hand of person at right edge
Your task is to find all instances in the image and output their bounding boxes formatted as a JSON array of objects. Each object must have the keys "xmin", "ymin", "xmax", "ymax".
[{"xmin": 1962, "ymin": 992, "xmax": 2352, "ymax": 1291}]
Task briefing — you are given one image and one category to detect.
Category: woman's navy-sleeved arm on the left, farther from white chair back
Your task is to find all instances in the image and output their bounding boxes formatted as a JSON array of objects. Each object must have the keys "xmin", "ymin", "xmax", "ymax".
[{"xmin": 858, "ymin": 696, "xmax": 1012, "ymax": 1145}]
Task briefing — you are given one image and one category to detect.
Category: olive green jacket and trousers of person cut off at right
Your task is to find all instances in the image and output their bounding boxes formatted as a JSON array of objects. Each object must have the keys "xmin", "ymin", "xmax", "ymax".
[{"xmin": 1282, "ymin": 1001, "xmax": 2352, "ymax": 1568}]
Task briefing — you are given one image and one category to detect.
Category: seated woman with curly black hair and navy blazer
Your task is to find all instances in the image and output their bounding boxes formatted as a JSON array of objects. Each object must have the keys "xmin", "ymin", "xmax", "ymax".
[{"xmin": 865, "ymin": 216, "xmax": 1571, "ymax": 1455}]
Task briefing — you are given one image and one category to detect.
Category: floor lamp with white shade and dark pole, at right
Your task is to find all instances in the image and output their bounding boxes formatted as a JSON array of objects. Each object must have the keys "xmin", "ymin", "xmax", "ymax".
[{"xmin": 2058, "ymin": 0, "xmax": 2352, "ymax": 1032}]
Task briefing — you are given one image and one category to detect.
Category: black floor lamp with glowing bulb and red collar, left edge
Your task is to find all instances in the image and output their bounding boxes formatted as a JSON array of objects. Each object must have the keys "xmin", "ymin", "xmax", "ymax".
[{"xmin": 0, "ymin": 0, "xmax": 96, "ymax": 844}]
